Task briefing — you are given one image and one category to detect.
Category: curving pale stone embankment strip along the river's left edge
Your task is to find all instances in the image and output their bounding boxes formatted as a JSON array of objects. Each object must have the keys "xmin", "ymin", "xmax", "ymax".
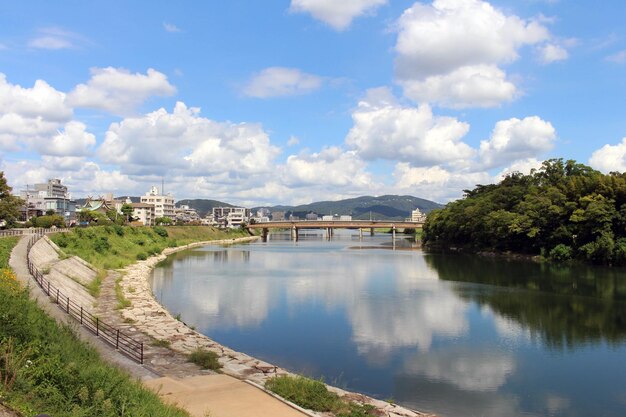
[{"xmin": 121, "ymin": 237, "xmax": 431, "ymax": 417}]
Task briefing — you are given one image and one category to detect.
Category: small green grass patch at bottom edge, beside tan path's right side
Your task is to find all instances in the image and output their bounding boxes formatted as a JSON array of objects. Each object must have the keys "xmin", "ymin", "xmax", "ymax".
[{"xmin": 265, "ymin": 375, "xmax": 376, "ymax": 417}]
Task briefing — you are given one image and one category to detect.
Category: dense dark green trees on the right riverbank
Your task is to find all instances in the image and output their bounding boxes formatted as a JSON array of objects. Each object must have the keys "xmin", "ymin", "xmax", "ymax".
[{"xmin": 423, "ymin": 159, "xmax": 626, "ymax": 265}]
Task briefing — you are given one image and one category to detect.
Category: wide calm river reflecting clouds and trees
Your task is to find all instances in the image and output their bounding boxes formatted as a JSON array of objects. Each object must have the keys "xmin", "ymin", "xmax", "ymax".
[{"xmin": 152, "ymin": 231, "xmax": 626, "ymax": 417}]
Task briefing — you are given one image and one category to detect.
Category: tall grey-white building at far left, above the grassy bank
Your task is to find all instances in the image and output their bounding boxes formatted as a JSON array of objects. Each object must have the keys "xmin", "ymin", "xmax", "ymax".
[{"xmin": 20, "ymin": 178, "xmax": 76, "ymax": 225}]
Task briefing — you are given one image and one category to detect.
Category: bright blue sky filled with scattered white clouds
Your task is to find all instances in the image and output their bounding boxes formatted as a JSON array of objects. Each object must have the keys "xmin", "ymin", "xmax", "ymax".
[{"xmin": 0, "ymin": 0, "xmax": 626, "ymax": 206}]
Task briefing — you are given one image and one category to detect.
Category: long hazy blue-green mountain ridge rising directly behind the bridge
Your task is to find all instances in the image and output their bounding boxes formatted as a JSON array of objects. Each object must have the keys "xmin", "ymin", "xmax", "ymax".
[{"xmin": 253, "ymin": 195, "xmax": 443, "ymax": 220}]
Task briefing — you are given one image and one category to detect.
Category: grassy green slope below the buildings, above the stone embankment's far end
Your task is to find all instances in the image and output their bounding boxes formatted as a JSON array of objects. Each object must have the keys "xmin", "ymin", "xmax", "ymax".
[{"xmin": 50, "ymin": 226, "xmax": 248, "ymax": 269}]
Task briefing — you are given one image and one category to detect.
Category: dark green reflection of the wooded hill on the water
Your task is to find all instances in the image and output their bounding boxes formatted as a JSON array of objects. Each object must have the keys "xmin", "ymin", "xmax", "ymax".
[{"xmin": 425, "ymin": 255, "xmax": 626, "ymax": 348}]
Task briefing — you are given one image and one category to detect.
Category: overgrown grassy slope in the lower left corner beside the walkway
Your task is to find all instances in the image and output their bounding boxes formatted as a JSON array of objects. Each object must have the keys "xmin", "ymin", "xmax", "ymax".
[{"xmin": 0, "ymin": 239, "xmax": 188, "ymax": 417}]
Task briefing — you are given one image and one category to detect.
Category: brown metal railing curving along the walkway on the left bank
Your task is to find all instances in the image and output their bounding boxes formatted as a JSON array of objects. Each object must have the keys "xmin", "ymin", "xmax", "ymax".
[{"xmin": 26, "ymin": 230, "xmax": 143, "ymax": 364}]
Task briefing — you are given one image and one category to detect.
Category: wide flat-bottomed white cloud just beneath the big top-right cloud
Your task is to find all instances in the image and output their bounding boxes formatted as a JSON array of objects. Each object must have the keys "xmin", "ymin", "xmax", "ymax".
[{"xmin": 402, "ymin": 65, "xmax": 518, "ymax": 108}]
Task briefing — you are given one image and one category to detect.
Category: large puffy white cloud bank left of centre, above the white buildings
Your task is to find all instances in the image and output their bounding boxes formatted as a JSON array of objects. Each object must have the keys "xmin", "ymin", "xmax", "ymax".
[{"xmin": 98, "ymin": 102, "xmax": 279, "ymax": 178}]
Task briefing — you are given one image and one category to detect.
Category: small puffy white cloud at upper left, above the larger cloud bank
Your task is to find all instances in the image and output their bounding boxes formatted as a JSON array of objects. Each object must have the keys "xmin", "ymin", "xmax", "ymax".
[{"xmin": 68, "ymin": 67, "xmax": 176, "ymax": 115}]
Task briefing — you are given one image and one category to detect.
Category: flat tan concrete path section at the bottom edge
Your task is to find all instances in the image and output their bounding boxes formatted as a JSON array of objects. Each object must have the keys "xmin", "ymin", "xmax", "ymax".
[{"xmin": 145, "ymin": 375, "xmax": 304, "ymax": 417}]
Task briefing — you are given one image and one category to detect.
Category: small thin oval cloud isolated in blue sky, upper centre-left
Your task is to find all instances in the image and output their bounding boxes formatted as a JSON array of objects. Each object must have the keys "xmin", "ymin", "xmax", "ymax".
[{"xmin": 243, "ymin": 67, "xmax": 322, "ymax": 98}]
